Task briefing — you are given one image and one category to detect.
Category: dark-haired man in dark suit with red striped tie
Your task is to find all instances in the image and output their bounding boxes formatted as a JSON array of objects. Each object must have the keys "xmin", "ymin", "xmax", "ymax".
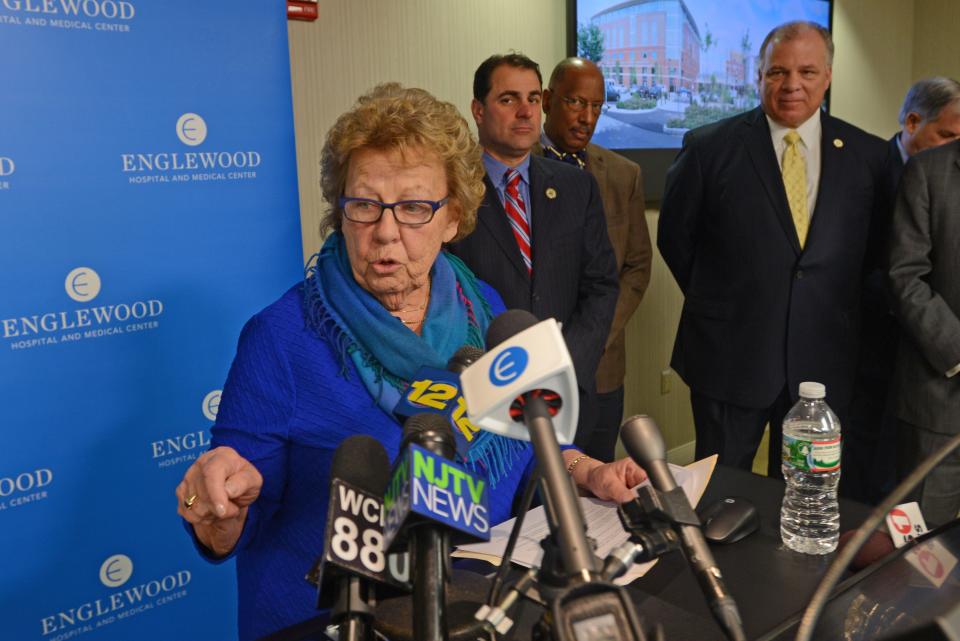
[{"xmin": 450, "ymin": 54, "xmax": 617, "ymax": 450}]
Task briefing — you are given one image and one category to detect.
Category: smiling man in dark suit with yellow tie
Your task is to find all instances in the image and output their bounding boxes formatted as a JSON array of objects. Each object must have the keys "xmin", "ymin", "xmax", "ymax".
[{"xmin": 657, "ymin": 22, "xmax": 886, "ymax": 476}]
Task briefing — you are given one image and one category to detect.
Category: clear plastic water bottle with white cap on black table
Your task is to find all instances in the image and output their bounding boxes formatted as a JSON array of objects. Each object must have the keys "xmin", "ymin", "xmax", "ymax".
[{"xmin": 780, "ymin": 383, "xmax": 840, "ymax": 554}]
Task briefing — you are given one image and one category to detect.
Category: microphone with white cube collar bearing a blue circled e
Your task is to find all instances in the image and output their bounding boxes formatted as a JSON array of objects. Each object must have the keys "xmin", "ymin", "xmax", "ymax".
[{"xmin": 460, "ymin": 309, "xmax": 600, "ymax": 582}]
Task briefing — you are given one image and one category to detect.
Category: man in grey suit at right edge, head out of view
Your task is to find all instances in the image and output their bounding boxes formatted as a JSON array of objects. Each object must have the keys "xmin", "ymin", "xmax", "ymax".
[{"xmin": 890, "ymin": 140, "xmax": 960, "ymax": 527}]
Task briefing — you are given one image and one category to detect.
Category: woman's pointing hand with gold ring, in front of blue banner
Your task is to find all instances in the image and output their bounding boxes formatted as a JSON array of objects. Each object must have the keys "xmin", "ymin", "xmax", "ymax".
[{"xmin": 177, "ymin": 447, "xmax": 263, "ymax": 556}]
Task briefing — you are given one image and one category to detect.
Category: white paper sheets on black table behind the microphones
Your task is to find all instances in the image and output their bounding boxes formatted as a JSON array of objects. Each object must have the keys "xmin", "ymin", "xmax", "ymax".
[{"xmin": 453, "ymin": 456, "xmax": 717, "ymax": 585}]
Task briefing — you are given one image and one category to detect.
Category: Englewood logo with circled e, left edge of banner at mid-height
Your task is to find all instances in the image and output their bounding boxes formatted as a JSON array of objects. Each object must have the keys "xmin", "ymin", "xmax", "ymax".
[{"xmin": 0, "ymin": 267, "xmax": 163, "ymax": 350}]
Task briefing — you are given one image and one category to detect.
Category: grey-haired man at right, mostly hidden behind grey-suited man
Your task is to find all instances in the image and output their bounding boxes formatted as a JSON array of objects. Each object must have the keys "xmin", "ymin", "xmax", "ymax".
[{"xmin": 840, "ymin": 77, "xmax": 960, "ymax": 504}]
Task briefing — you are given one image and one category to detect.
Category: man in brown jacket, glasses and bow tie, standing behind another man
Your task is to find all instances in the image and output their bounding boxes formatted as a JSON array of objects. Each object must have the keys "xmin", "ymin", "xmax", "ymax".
[{"xmin": 534, "ymin": 58, "xmax": 653, "ymax": 461}]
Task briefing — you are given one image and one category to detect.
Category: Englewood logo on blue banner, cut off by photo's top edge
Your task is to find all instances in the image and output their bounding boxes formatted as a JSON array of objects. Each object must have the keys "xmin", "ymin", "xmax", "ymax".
[{"xmin": 0, "ymin": 0, "xmax": 137, "ymax": 33}]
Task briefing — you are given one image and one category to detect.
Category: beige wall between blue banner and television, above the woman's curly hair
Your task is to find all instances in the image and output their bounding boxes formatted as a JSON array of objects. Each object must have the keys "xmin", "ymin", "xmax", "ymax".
[{"xmin": 289, "ymin": 0, "xmax": 566, "ymax": 257}]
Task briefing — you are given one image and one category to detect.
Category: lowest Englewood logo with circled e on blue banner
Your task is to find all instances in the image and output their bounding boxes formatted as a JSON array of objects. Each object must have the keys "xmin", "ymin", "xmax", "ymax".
[{"xmin": 40, "ymin": 554, "xmax": 193, "ymax": 641}]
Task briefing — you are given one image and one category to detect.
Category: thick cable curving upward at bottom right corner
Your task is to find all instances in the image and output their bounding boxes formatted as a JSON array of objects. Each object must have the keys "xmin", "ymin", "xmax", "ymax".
[{"xmin": 796, "ymin": 434, "xmax": 960, "ymax": 641}]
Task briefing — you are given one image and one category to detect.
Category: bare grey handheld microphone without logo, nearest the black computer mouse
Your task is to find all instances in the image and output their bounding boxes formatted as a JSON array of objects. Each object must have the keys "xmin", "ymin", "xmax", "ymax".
[{"xmin": 620, "ymin": 415, "xmax": 746, "ymax": 641}]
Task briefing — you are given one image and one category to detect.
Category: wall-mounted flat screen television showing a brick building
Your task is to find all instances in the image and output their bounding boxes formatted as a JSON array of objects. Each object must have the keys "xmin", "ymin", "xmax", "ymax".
[{"xmin": 567, "ymin": 0, "xmax": 833, "ymax": 202}]
